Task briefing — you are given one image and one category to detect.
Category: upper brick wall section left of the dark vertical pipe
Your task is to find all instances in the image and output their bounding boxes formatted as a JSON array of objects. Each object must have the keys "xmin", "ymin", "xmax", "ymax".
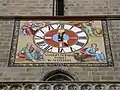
[{"xmin": 0, "ymin": 0, "xmax": 52, "ymax": 16}]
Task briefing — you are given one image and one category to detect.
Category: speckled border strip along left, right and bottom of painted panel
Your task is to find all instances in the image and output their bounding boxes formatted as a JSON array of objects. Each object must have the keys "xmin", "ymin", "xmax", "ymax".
[{"xmin": 8, "ymin": 18, "xmax": 114, "ymax": 67}]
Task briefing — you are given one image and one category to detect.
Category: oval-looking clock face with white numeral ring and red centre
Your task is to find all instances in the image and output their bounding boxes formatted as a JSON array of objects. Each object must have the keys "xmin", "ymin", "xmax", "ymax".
[{"xmin": 33, "ymin": 23, "xmax": 88, "ymax": 53}]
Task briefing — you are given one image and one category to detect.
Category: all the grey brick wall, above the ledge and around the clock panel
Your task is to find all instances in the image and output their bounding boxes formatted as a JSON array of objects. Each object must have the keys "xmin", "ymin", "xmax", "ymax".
[{"xmin": 0, "ymin": 0, "xmax": 120, "ymax": 82}]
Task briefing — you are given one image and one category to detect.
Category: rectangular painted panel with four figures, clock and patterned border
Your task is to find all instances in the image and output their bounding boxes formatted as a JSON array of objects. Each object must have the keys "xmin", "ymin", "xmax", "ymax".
[{"xmin": 9, "ymin": 20, "xmax": 113, "ymax": 67}]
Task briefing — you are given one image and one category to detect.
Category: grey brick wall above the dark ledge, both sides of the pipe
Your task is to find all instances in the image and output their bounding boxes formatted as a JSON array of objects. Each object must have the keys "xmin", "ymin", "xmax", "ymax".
[{"xmin": 0, "ymin": 0, "xmax": 120, "ymax": 16}]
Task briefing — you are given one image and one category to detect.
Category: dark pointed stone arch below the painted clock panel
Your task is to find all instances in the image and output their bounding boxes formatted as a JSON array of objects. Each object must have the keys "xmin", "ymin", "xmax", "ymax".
[{"xmin": 43, "ymin": 70, "xmax": 75, "ymax": 81}]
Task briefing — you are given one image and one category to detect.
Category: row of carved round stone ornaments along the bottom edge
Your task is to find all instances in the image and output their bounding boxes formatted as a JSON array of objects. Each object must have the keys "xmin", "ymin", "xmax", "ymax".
[{"xmin": 0, "ymin": 82, "xmax": 120, "ymax": 90}]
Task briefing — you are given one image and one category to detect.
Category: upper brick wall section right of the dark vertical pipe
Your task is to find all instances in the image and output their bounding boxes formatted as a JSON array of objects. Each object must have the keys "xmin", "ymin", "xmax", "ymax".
[{"xmin": 65, "ymin": 0, "xmax": 120, "ymax": 16}]
